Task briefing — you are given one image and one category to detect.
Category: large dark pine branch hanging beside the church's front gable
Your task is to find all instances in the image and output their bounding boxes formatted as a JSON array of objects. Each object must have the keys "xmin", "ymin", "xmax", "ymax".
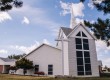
[{"xmin": 84, "ymin": 18, "xmax": 110, "ymax": 46}]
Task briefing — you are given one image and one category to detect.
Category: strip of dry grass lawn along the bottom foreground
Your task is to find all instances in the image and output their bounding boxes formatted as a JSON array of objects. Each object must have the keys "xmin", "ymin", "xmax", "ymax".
[{"xmin": 0, "ymin": 74, "xmax": 110, "ymax": 80}]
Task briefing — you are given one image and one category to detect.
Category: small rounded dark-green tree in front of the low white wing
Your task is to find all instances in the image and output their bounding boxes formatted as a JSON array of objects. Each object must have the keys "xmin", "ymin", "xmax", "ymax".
[{"xmin": 16, "ymin": 58, "xmax": 33, "ymax": 75}]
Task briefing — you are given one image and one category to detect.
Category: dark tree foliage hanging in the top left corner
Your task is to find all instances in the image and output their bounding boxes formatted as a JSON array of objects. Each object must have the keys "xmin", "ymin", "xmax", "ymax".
[{"xmin": 0, "ymin": 0, "xmax": 23, "ymax": 11}]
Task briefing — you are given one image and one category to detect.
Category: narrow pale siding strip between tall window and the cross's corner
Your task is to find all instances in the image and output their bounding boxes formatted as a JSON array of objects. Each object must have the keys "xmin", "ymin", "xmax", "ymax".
[{"xmin": 68, "ymin": 37, "xmax": 77, "ymax": 76}]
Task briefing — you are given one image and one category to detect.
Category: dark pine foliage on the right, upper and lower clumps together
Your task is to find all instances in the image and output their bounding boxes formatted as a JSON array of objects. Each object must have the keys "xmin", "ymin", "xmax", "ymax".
[{"xmin": 80, "ymin": 0, "xmax": 110, "ymax": 46}]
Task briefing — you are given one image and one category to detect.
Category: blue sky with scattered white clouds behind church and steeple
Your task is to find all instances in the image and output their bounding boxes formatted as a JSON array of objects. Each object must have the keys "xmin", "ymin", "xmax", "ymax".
[{"xmin": 0, "ymin": 0, "xmax": 110, "ymax": 67}]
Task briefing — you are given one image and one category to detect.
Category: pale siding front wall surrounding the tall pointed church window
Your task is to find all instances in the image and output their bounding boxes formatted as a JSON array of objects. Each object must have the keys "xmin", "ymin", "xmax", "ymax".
[{"xmin": 68, "ymin": 26, "xmax": 99, "ymax": 77}]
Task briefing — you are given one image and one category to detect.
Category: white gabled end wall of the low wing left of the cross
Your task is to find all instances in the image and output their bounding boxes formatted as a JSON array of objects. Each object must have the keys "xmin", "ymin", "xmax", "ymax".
[{"xmin": 16, "ymin": 45, "xmax": 62, "ymax": 75}]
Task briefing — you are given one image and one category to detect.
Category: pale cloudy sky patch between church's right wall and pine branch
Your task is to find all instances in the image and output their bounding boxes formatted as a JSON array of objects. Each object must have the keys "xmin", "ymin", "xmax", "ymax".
[{"xmin": 96, "ymin": 40, "xmax": 110, "ymax": 67}]
